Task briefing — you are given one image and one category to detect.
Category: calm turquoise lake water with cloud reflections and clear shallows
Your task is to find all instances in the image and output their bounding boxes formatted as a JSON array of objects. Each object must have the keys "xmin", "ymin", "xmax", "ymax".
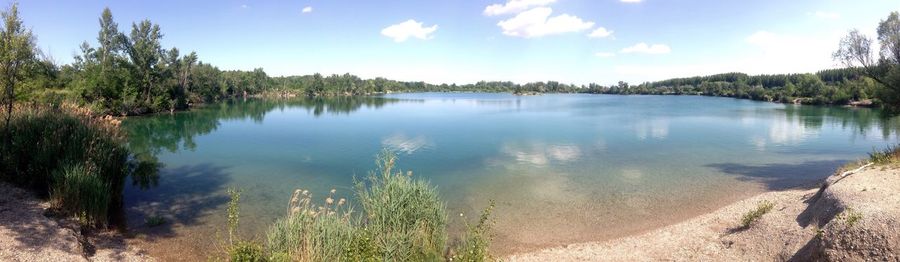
[{"xmin": 123, "ymin": 93, "xmax": 900, "ymax": 253}]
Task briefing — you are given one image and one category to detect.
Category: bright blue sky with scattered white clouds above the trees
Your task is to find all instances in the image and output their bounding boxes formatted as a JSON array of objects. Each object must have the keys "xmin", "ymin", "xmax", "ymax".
[{"xmin": 7, "ymin": 0, "xmax": 900, "ymax": 84}]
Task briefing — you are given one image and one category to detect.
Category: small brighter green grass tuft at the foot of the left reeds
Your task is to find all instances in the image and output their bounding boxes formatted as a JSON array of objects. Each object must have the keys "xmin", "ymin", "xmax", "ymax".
[{"xmin": 50, "ymin": 164, "xmax": 112, "ymax": 225}]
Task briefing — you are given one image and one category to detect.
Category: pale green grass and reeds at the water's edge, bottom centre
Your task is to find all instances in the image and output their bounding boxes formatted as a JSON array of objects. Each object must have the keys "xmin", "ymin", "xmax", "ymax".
[{"xmin": 225, "ymin": 151, "xmax": 493, "ymax": 261}]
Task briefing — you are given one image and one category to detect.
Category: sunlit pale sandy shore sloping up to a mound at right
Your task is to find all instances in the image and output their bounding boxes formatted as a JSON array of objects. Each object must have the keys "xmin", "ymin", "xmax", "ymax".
[{"xmin": 504, "ymin": 167, "xmax": 900, "ymax": 261}]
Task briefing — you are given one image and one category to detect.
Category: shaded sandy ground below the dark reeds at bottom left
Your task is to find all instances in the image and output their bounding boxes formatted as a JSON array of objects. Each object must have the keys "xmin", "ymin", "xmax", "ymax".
[{"xmin": 0, "ymin": 183, "xmax": 153, "ymax": 262}]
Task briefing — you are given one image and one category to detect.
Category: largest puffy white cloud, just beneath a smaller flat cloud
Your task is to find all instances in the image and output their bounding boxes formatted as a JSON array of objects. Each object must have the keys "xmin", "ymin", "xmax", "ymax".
[{"xmin": 497, "ymin": 7, "xmax": 594, "ymax": 38}]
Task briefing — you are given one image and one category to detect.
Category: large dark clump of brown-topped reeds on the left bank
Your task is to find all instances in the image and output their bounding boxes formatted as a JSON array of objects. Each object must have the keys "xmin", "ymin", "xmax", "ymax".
[{"xmin": 0, "ymin": 105, "xmax": 156, "ymax": 227}]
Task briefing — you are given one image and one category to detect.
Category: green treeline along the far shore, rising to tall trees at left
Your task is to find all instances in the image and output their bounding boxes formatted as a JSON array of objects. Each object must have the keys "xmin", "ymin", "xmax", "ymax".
[{"xmin": 15, "ymin": 9, "xmax": 900, "ymax": 115}]
